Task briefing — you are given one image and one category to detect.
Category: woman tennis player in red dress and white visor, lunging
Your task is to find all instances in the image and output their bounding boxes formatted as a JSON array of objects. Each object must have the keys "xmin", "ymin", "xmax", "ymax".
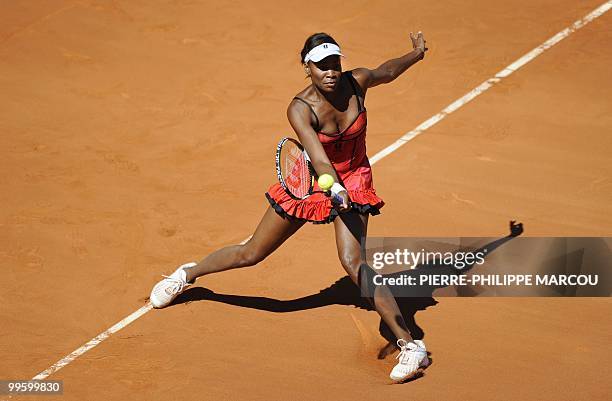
[{"xmin": 150, "ymin": 32, "xmax": 429, "ymax": 382}]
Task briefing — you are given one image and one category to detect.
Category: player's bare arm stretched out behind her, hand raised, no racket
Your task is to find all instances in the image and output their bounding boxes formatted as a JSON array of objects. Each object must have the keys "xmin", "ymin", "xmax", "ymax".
[{"xmin": 353, "ymin": 32, "xmax": 428, "ymax": 90}]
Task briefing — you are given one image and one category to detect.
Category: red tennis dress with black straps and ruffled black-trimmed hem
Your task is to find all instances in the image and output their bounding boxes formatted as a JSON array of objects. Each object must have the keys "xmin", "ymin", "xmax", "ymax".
[{"xmin": 266, "ymin": 71, "xmax": 385, "ymax": 224}]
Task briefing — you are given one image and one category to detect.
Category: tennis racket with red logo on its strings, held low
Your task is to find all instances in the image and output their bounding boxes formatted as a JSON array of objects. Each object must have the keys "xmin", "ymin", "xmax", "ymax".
[{"xmin": 276, "ymin": 138, "xmax": 342, "ymax": 205}]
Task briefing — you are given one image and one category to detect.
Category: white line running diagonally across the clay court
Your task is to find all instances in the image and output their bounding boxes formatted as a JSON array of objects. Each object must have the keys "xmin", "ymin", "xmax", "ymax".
[{"xmin": 32, "ymin": 0, "xmax": 612, "ymax": 380}]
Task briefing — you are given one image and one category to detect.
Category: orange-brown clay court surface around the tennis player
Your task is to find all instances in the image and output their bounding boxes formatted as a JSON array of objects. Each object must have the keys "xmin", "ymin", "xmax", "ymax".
[{"xmin": 0, "ymin": 0, "xmax": 612, "ymax": 401}]
